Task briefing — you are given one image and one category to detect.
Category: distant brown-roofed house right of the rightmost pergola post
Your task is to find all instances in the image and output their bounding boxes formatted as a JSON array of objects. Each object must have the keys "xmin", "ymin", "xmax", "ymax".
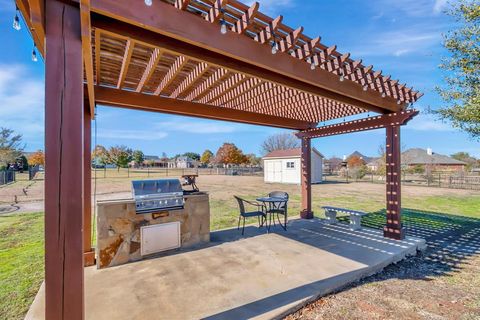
[{"xmin": 402, "ymin": 148, "xmax": 467, "ymax": 171}]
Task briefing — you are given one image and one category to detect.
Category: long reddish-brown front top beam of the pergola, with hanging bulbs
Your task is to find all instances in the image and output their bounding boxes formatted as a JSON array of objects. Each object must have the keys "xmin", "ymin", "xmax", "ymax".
[{"xmin": 91, "ymin": 0, "xmax": 402, "ymax": 113}]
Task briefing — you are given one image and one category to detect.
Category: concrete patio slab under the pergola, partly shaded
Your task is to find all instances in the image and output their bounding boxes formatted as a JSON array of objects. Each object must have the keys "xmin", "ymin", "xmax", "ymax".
[{"xmin": 27, "ymin": 219, "xmax": 425, "ymax": 320}]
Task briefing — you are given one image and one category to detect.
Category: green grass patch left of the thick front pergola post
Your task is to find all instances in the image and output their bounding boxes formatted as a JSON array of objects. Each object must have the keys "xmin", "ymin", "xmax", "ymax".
[{"xmin": 0, "ymin": 213, "xmax": 44, "ymax": 319}]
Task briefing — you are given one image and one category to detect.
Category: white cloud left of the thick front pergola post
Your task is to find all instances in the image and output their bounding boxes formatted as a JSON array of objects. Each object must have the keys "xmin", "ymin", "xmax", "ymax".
[{"xmin": 0, "ymin": 64, "xmax": 44, "ymax": 150}]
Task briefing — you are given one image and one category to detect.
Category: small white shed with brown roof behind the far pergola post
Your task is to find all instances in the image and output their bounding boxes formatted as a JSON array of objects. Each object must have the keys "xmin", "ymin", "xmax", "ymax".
[{"xmin": 262, "ymin": 148, "xmax": 324, "ymax": 184}]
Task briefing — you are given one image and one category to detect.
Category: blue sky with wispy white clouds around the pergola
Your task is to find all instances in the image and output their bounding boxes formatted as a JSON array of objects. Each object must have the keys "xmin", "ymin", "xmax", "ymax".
[{"xmin": 0, "ymin": 0, "xmax": 480, "ymax": 157}]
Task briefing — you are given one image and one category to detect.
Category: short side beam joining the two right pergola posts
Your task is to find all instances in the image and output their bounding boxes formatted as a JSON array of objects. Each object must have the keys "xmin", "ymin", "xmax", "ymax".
[{"xmin": 297, "ymin": 110, "xmax": 419, "ymax": 138}]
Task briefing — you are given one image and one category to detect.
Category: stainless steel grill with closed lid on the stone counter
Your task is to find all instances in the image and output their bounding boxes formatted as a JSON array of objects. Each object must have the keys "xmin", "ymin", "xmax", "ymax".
[{"xmin": 132, "ymin": 179, "xmax": 184, "ymax": 214}]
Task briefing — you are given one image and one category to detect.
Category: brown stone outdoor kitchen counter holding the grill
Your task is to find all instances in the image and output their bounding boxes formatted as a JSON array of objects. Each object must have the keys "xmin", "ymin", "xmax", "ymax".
[{"xmin": 96, "ymin": 192, "xmax": 210, "ymax": 268}]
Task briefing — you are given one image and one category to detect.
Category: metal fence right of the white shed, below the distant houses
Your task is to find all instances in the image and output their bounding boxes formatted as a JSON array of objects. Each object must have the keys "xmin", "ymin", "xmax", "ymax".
[{"xmin": 324, "ymin": 172, "xmax": 480, "ymax": 190}]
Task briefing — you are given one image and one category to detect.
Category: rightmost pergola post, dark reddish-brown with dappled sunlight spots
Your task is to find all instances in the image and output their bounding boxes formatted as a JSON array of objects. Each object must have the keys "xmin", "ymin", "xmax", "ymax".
[{"xmin": 383, "ymin": 126, "xmax": 405, "ymax": 240}]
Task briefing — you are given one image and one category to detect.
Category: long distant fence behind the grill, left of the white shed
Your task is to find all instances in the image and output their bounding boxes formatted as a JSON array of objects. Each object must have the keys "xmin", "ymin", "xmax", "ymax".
[{"xmin": 92, "ymin": 167, "xmax": 263, "ymax": 179}]
